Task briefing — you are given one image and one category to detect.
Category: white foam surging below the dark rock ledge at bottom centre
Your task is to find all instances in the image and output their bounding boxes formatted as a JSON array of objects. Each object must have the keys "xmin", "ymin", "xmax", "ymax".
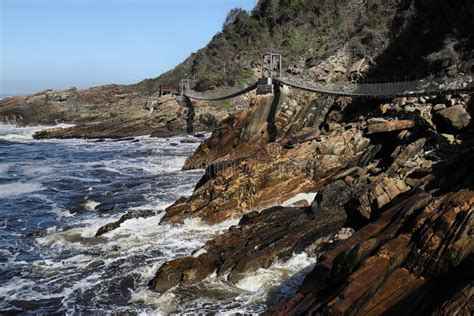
[{"xmin": 129, "ymin": 230, "xmax": 316, "ymax": 315}]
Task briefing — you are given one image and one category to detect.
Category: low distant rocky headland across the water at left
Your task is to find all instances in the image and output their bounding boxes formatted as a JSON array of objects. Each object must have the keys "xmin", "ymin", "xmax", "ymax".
[{"xmin": 0, "ymin": 85, "xmax": 234, "ymax": 139}]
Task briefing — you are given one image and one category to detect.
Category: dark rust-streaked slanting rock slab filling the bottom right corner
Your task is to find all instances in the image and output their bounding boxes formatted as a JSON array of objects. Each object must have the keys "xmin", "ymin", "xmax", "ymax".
[{"xmin": 275, "ymin": 189, "xmax": 474, "ymax": 315}]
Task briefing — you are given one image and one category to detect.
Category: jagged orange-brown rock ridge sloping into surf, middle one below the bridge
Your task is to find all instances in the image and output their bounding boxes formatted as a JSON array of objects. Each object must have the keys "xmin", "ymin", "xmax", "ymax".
[{"xmin": 162, "ymin": 123, "xmax": 369, "ymax": 223}]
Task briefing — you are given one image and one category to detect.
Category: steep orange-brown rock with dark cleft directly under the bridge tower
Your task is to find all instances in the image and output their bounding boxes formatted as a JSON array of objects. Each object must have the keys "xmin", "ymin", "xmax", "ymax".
[{"xmin": 184, "ymin": 91, "xmax": 335, "ymax": 169}]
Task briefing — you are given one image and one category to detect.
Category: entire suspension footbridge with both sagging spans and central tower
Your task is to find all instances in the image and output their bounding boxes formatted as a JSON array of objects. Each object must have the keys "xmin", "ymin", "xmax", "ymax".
[{"xmin": 162, "ymin": 54, "xmax": 474, "ymax": 101}]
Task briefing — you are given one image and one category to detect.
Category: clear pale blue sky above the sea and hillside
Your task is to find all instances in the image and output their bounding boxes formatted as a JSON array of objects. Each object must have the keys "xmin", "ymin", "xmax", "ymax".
[{"xmin": 0, "ymin": 0, "xmax": 256, "ymax": 94}]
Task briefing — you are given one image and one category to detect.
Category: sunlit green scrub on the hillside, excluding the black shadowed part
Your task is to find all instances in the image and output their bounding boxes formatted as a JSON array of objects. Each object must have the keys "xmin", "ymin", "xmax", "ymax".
[{"xmin": 139, "ymin": 0, "xmax": 404, "ymax": 93}]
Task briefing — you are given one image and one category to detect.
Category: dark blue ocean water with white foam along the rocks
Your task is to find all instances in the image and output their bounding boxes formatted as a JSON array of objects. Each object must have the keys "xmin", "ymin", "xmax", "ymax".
[{"xmin": 0, "ymin": 125, "xmax": 316, "ymax": 315}]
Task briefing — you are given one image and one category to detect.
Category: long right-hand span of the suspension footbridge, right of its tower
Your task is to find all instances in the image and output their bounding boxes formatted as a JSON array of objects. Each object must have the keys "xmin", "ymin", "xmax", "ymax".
[{"xmin": 275, "ymin": 74, "xmax": 474, "ymax": 98}]
